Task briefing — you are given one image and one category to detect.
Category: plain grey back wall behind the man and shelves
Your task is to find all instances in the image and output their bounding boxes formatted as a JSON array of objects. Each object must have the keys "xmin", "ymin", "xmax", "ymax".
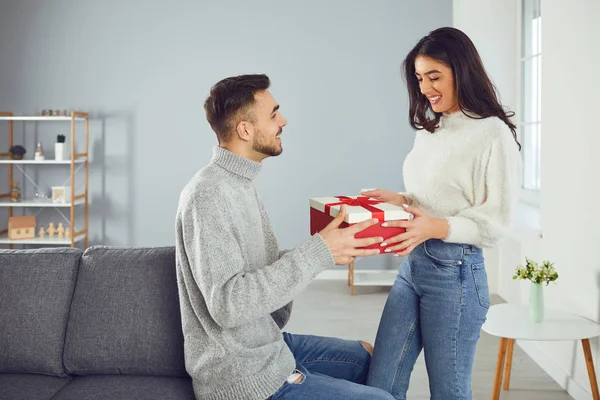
[{"xmin": 0, "ymin": 0, "xmax": 452, "ymax": 267}]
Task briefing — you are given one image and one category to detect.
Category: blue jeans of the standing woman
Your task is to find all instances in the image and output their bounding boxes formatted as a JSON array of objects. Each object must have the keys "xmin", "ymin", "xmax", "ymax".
[{"xmin": 367, "ymin": 239, "xmax": 490, "ymax": 400}]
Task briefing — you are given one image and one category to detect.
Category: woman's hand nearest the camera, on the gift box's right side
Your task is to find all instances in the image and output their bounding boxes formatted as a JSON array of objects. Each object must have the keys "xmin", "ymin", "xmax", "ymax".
[{"xmin": 381, "ymin": 204, "xmax": 449, "ymax": 256}]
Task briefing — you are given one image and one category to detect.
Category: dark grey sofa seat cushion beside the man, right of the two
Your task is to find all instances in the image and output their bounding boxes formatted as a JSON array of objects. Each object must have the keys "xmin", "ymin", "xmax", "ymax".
[{"xmin": 52, "ymin": 375, "xmax": 195, "ymax": 400}]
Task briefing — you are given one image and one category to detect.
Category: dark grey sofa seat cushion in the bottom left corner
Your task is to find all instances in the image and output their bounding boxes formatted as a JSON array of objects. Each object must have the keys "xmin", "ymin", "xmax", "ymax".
[{"xmin": 0, "ymin": 374, "xmax": 71, "ymax": 400}]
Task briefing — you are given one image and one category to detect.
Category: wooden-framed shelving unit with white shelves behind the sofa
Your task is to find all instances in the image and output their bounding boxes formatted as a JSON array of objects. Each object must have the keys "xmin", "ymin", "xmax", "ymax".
[{"xmin": 0, "ymin": 111, "xmax": 89, "ymax": 248}]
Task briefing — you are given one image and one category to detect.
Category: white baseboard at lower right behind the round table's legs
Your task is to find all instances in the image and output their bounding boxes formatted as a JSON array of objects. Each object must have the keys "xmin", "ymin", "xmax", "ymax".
[{"xmin": 517, "ymin": 340, "xmax": 592, "ymax": 400}]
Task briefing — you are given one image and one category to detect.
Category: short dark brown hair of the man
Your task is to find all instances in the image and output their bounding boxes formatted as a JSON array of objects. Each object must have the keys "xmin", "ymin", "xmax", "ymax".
[{"xmin": 204, "ymin": 74, "xmax": 271, "ymax": 143}]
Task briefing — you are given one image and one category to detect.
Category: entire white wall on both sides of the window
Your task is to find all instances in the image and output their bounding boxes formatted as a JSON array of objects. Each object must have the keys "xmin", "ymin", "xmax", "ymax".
[{"xmin": 454, "ymin": 0, "xmax": 600, "ymax": 399}]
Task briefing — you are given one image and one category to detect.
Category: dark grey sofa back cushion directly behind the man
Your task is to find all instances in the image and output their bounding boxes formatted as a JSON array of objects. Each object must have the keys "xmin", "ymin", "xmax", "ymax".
[{"xmin": 64, "ymin": 246, "xmax": 188, "ymax": 377}]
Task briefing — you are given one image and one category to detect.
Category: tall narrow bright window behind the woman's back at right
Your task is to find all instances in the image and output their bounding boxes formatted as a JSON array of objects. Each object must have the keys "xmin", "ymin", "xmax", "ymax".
[{"xmin": 519, "ymin": 0, "xmax": 542, "ymax": 198}]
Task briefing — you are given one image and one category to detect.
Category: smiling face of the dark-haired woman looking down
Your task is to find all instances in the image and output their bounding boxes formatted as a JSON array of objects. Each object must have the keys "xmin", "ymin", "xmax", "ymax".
[{"xmin": 415, "ymin": 55, "xmax": 460, "ymax": 114}]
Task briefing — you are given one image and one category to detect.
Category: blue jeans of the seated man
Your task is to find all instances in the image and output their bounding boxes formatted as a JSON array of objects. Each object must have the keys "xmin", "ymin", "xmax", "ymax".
[{"xmin": 270, "ymin": 333, "xmax": 394, "ymax": 400}]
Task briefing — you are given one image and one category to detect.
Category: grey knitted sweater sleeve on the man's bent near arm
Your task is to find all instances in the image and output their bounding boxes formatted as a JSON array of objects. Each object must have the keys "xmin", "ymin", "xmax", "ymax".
[{"xmin": 179, "ymin": 195, "xmax": 334, "ymax": 328}]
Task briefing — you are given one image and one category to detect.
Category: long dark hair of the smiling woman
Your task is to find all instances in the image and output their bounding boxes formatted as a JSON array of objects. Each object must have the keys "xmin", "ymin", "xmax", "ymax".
[{"xmin": 403, "ymin": 27, "xmax": 521, "ymax": 150}]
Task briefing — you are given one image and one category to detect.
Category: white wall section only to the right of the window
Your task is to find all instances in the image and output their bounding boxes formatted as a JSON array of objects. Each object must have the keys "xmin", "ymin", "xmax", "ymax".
[{"xmin": 540, "ymin": 0, "xmax": 600, "ymax": 396}]
